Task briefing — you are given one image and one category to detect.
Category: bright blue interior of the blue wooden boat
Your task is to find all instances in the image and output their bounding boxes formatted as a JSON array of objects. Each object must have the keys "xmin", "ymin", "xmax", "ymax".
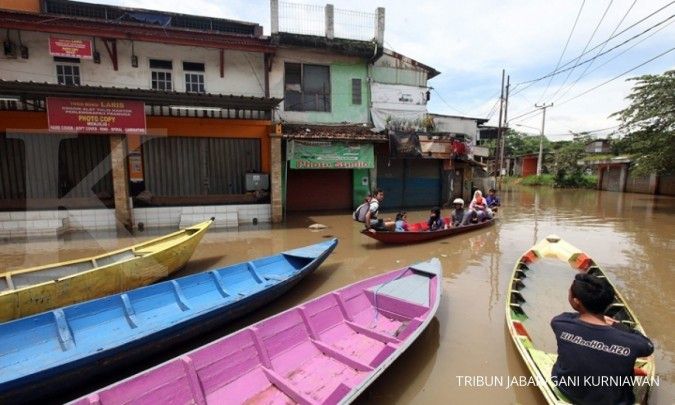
[{"xmin": 0, "ymin": 254, "xmax": 312, "ymax": 372}]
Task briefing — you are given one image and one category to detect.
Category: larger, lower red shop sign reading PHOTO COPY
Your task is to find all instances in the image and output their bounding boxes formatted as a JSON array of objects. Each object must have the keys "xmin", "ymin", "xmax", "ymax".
[{"xmin": 47, "ymin": 97, "xmax": 146, "ymax": 134}]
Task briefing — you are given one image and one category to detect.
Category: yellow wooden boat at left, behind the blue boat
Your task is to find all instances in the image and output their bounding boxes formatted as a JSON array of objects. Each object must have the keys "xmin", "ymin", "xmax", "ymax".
[{"xmin": 0, "ymin": 218, "xmax": 213, "ymax": 322}]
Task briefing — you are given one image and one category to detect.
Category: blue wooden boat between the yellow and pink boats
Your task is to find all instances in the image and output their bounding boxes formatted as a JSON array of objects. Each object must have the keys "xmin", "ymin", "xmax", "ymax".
[{"xmin": 0, "ymin": 239, "xmax": 337, "ymax": 403}]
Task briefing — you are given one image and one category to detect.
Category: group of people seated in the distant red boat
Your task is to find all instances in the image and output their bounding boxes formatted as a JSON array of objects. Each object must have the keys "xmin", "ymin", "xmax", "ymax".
[{"xmin": 353, "ymin": 188, "xmax": 501, "ymax": 232}]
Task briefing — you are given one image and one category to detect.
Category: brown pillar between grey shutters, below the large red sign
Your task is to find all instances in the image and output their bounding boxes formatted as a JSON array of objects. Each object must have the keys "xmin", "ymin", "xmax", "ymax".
[{"xmin": 110, "ymin": 135, "xmax": 134, "ymax": 230}]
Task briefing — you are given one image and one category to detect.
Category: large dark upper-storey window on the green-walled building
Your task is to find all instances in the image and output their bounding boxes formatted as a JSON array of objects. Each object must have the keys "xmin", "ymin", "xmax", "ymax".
[{"xmin": 284, "ymin": 63, "xmax": 330, "ymax": 111}]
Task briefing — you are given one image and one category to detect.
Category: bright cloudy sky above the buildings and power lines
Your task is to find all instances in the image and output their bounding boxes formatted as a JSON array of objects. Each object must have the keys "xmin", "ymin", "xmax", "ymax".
[{"xmin": 94, "ymin": 0, "xmax": 675, "ymax": 140}]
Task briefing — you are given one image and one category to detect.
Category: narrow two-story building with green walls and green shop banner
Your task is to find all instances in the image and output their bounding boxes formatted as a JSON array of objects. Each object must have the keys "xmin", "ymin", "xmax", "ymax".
[{"xmin": 270, "ymin": 0, "xmax": 386, "ymax": 218}]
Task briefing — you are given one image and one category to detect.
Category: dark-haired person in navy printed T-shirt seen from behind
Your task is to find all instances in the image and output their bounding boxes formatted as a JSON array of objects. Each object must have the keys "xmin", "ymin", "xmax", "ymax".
[{"xmin": 551, "ymin": 273, "xmax": 654, "ymax": 404}]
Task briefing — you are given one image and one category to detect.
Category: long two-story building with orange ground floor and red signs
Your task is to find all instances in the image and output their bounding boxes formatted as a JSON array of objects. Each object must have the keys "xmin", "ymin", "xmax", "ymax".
[{"xmin": 0, "ymin": 0, "xmax": 283, "ymax": 234}]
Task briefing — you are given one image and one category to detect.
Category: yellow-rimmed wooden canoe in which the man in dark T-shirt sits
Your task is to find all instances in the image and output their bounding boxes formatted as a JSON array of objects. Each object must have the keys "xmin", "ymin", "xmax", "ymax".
[{"xmin": 506, "ymin": 235, "xmax": 655, "ymax": 404}]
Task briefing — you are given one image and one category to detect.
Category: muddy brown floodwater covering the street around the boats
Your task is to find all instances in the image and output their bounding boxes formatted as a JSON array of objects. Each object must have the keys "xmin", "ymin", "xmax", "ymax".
[{"xmin": 0, "ymin": 188, "xmax": 675, "ymax": 404}]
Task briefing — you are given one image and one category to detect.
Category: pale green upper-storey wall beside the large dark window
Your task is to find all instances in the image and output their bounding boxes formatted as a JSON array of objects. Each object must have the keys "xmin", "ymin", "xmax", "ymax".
[{"xmin": 307, "ymin": 62, "xmax": 370, "ymax": 123}]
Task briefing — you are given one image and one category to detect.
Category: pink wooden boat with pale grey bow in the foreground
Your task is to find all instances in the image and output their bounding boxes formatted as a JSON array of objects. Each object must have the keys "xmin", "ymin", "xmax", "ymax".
[{"xmin": 74, "ymin": 258, "xmax": 442, "ymax": 405}]
